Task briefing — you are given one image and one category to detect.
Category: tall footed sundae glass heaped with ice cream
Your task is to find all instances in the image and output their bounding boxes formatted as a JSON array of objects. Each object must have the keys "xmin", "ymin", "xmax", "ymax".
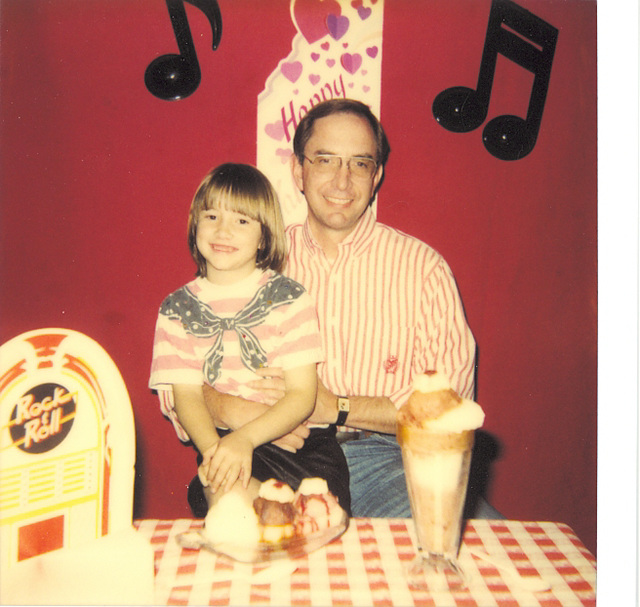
[{"xmin": 397, "ymin": 373, "xmax": 484, "ymax": 589}]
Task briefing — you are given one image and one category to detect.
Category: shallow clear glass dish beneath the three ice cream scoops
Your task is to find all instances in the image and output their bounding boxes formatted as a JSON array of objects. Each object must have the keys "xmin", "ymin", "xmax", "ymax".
[{"xmin": 176, "ymin": 510, "xmax": 349, "ymax": 563}]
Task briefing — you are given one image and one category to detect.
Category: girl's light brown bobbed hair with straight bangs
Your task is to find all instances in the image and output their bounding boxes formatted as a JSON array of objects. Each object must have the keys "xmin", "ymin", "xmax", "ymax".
[{"xmin": 188, "ymin": 163, "xmax": 287, "ymax": 276}]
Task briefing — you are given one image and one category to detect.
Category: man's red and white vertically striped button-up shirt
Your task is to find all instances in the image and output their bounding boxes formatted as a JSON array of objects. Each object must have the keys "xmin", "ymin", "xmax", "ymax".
[{"xmin": 285, "ymin": 209, "xmax": 476, "ymax": 407}]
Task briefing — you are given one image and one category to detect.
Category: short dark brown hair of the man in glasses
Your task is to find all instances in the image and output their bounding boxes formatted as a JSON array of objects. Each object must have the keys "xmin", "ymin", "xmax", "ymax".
[{"xmin": 293, "ymin": 99, "xmax": 391, "ymax": 166}]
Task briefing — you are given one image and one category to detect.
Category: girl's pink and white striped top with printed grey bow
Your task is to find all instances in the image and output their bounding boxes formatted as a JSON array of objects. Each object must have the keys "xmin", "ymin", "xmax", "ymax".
[{"xmin": 149, "ymin": 270, "xmax": 322, "ymax": 441}]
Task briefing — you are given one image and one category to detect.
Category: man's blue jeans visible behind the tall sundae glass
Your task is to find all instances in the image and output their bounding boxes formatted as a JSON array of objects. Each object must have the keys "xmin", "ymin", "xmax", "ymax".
[{"xmin": 341, "ymin": 433, "xmax": 504, "ymax": 519}]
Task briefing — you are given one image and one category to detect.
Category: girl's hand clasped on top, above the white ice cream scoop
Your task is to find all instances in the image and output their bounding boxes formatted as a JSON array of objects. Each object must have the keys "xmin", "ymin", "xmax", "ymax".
[{"xmin": 202, "ymin": 432, "xmax": 254, "ymax": 493}]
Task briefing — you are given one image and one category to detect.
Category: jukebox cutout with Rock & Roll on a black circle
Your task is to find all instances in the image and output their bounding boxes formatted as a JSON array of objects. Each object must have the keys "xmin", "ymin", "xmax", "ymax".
[{"xmin": 0, "ymin": 329, "xmax": 153, "ymax": 603}]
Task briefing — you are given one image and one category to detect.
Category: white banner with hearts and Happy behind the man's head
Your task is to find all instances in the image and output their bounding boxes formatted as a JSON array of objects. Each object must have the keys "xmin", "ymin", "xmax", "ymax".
[{"xmin": 257, "ymin": 0, "xmax": 384, "ymax": 225}]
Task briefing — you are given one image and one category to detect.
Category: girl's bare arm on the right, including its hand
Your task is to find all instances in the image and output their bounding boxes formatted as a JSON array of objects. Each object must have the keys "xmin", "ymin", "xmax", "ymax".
[{"xmin": 209, "ymin": 363, "xmax": 317, "ymax": 492}]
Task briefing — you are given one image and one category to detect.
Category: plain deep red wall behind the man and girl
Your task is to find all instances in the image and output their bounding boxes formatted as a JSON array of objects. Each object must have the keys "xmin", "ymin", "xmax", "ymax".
[{"xmin": 0, "ymin": 0, "xmax": 597, "ymax": 551}]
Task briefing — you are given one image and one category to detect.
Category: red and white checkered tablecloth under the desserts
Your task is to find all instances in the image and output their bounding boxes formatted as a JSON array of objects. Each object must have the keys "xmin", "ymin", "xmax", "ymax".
[{"xmin": 135, "ymin": 518, "xmax": 596, "ymax": 607}]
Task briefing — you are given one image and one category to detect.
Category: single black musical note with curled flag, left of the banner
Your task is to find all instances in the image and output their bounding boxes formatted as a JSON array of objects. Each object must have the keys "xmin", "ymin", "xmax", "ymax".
[{"xmin": 144, "ymin": 0, "xmax": 222, "ymax": 101}]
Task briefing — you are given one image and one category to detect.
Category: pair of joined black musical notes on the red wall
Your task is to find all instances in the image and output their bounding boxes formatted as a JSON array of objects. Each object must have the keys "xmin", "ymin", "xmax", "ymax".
[{"xmin": 432, "ymin": 0, "xmax": 558, "ymax": 160}]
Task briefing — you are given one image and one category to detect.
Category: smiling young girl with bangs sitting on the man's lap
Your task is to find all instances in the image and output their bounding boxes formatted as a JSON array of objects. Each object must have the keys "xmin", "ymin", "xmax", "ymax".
[{"xmin": 149, "ymin": 164, "xmax": 350, "ymax": 517}]
